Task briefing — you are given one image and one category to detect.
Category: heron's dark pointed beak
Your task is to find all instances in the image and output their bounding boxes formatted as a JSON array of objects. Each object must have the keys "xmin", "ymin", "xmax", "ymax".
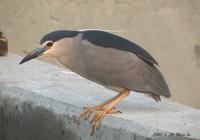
[{"xmin": 19, "ymin": 47, "xmax": 49, "ymax": 64}]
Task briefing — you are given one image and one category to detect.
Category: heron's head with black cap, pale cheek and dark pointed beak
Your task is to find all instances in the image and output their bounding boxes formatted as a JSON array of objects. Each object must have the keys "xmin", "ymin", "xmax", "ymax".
[{"xmin": 19, "ymin": 30, "xmax": 79, "ymax": 64}]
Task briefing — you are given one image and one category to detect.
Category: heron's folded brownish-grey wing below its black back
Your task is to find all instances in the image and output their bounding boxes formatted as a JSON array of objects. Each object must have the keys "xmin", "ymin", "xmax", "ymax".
[{"xmin": 77, "ymin": 41, "xmax": 170, "ymax": 97}]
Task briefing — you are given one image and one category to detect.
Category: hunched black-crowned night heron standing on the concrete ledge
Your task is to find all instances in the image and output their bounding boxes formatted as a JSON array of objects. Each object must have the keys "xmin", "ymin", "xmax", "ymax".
[{"xmin": 20, "ymin": 30, "xmax": 170, "ymax": 134}]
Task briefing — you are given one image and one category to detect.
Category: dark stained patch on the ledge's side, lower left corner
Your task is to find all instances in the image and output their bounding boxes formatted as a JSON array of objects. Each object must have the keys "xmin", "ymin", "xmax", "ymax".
[{"xmin": 0, "ymin": 99, "xmax": 80, "ymax": 140}]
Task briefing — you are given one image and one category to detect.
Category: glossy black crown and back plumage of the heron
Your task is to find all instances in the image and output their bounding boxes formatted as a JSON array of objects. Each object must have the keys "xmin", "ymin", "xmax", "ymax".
[{"xmin": 40, "ymin": 30, "xmax": 158, "ymax": 65}]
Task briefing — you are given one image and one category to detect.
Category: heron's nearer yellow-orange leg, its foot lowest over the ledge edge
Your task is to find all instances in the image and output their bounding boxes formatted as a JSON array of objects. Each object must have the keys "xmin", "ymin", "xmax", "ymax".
[{"xmin": 90, "ymin": 90, "xmax": 129, "ymax": 135}]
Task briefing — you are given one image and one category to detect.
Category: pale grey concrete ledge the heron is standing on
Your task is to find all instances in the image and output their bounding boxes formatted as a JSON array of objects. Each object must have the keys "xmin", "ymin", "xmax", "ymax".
[{"xmin": 0, "ymin": 54, "xmax": 200, "ymax": 140}]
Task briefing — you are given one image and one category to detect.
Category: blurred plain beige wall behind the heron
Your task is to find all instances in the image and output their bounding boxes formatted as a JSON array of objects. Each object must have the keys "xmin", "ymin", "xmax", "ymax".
[{"xmin": 0, "ymin": 0, "xmax": 200, "ymax": 108}]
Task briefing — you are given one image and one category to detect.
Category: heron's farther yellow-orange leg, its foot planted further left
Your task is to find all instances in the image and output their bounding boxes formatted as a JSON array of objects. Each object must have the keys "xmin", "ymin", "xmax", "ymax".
[{"xmin": 75, "ymin": 94, "xmax": 120, "ymax": 124}]
